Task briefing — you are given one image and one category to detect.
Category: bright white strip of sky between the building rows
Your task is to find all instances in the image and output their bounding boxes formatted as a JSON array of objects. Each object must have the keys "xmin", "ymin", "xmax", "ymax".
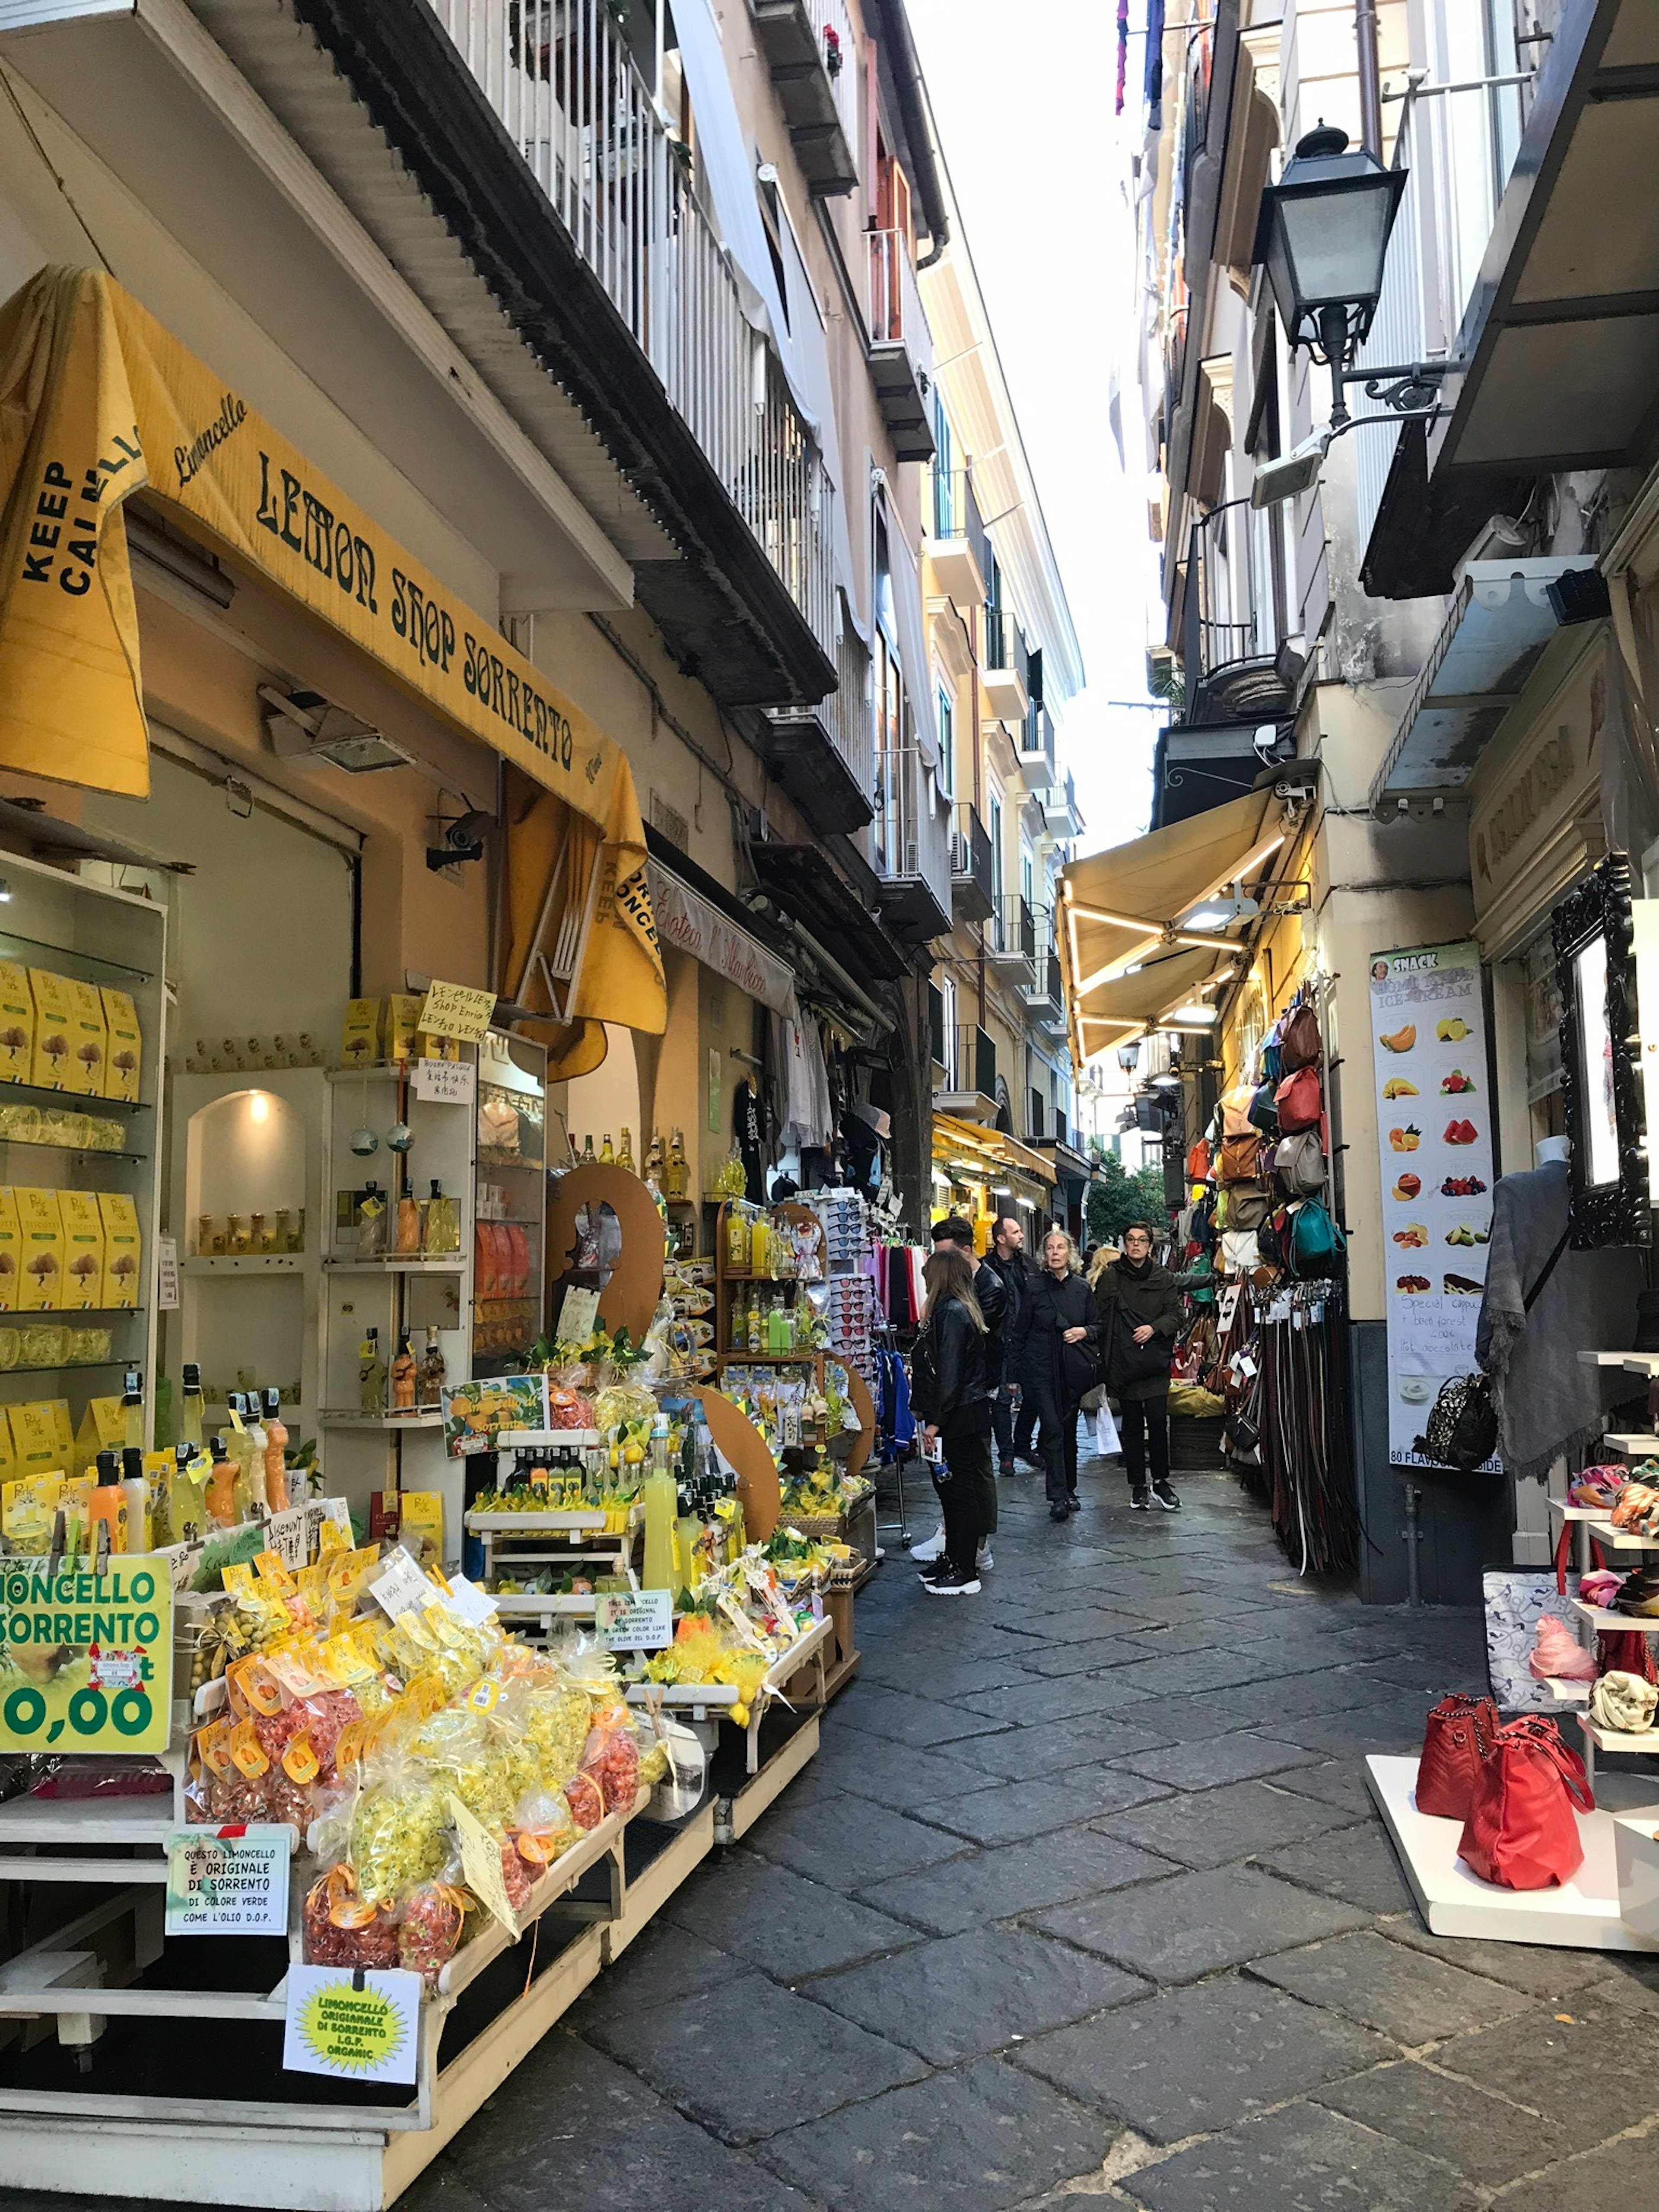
[{"xmin": 907, "ymin": 0, "xmax": 1159, "ymax": 852}]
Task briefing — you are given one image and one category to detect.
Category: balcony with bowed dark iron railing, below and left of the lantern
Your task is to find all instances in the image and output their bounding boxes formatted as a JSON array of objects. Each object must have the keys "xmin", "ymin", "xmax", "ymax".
[{"xmin": 1181, "ymin": 500, "xmax": 1292, "ymax": 725}]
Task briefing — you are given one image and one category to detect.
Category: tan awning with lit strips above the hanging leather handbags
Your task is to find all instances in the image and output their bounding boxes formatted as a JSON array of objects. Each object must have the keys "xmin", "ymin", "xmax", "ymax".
[{"xmin": 1059, "ymin": 792, "xmax": 1290, "ymax": 1064}]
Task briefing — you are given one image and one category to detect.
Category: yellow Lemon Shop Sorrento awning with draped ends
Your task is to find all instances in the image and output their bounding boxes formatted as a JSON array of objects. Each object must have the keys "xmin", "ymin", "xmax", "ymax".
[{"xmin": 0, "ymin": 268, "xmax": 666, "ymax": 1053}]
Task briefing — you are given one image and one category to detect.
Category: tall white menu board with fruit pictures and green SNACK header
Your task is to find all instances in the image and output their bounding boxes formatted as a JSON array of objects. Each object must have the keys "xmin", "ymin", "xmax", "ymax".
[{"xmin": 1371, "ymin": 944, "xmax": 1493, "ymax": 1467}]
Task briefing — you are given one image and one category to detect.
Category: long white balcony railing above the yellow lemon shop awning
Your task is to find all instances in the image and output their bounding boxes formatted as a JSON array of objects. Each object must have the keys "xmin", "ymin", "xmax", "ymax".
[{"xmin": 431, "ymin": 0, "xmax": 847, "ymax": 652}]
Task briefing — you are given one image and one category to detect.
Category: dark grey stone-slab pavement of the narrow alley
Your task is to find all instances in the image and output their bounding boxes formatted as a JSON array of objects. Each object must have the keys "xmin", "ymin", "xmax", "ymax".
[{"xmin": 13, "ymin": 1467, "xmax": 1659, "ymax": 2212}]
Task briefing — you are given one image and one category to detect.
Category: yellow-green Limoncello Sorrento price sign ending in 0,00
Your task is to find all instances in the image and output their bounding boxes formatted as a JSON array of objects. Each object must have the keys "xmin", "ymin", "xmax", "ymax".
[{"xmin": 0, "ymin": 1553, "xmax": 172, "ymax": 1754}]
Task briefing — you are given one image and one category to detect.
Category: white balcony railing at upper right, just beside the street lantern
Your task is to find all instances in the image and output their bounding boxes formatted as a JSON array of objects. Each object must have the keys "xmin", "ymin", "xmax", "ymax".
[{"xmin": 1349, "ymin": 78, "xmax": 1540, "ymax": 562}]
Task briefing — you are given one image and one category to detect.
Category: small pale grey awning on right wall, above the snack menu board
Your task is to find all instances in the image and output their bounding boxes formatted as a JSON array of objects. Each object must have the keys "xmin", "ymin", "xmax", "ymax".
[{"xmin": 1371, "ymin": 557, "xmax": 1588, "ymax": 805}]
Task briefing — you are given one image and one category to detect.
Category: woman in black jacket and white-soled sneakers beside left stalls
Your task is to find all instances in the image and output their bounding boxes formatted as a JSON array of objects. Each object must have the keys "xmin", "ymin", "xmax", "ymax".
[{"xmin": 911, "ymin": 1243, "xmax": 995, "ymax": 1597}]
